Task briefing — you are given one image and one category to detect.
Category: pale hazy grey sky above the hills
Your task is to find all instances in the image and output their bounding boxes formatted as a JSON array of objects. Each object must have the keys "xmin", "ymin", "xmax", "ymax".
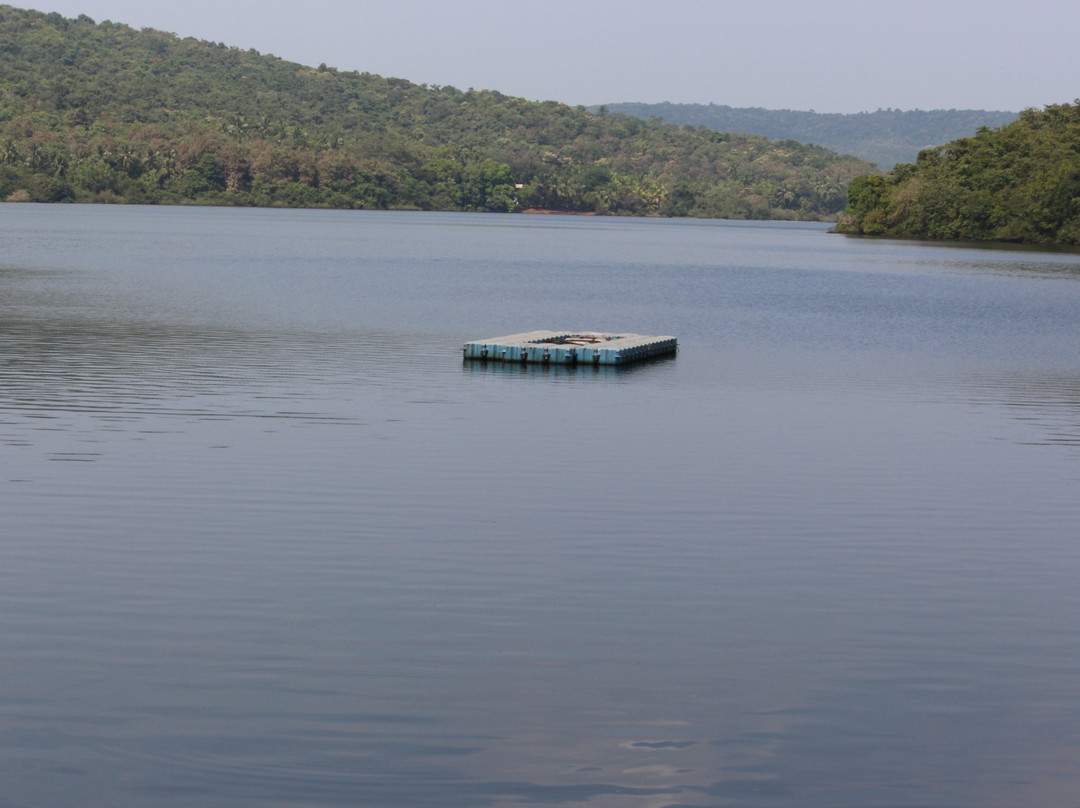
[{"xmin": 19, "ymin": 0, "xmax": 1080, "ymax": 112}]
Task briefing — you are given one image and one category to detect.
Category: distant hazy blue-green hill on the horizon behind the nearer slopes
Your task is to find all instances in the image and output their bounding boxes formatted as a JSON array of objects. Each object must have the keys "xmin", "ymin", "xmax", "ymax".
[{"xmin": 606, "ymin": 104, "xmax": 1016, "ymax": 169}]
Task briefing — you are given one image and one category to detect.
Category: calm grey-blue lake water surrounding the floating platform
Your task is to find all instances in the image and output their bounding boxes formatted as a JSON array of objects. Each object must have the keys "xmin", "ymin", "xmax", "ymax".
[{"xmin": 0, "ymin": 204, "xmax": 1080, "ymax": 808}]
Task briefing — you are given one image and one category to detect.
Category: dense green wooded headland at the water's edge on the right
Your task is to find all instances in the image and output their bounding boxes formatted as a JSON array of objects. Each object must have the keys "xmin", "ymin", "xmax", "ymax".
[{"xmin": 837, "ymin": 102, "xmax": 1080, "ymax": 244}]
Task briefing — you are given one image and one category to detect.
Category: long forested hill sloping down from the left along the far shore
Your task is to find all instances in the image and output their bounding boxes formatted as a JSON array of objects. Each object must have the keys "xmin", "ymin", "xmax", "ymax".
[{"xmin": 0, "ymin": 5, "xmax": 874, "ymax": 219}]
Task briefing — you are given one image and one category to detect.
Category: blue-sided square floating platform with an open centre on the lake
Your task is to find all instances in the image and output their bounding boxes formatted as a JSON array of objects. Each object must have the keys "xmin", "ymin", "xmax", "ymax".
[{"xmin": 463, "ymin": 331, "xmax": 678, "ymax": 365}]
